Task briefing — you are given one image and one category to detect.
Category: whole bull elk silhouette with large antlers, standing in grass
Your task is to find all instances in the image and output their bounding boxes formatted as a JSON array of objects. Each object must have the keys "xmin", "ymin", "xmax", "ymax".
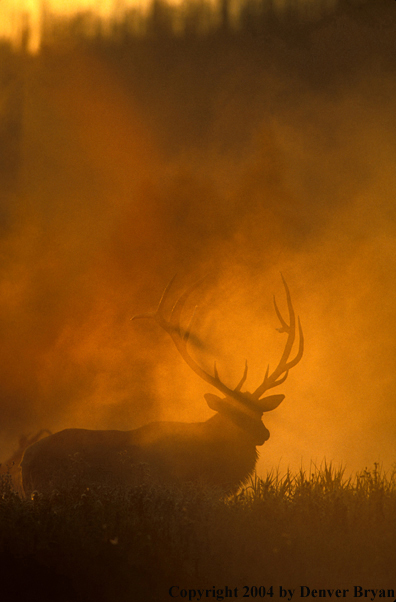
[{"xmin": 21, "ymin": 276, "xmax": 304, "ymax": 496}]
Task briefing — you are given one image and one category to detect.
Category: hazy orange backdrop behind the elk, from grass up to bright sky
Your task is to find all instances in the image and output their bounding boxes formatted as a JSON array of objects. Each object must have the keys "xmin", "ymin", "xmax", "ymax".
[{"xmin": 0, "ymin": 1, "xmax": 396, "ymax": 474}]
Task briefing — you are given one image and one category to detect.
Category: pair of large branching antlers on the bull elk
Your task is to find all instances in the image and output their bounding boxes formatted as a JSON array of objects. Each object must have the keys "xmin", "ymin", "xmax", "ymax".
[{"xmin": 132, "ymin": 276, "xmax": 304, "ymax": 412}]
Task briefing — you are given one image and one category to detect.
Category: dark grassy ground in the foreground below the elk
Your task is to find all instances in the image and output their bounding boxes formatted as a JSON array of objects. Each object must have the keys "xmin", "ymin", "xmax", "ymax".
[{"xmin": 0, "ymin": 465, "xmax": 396, "ymax": 601}]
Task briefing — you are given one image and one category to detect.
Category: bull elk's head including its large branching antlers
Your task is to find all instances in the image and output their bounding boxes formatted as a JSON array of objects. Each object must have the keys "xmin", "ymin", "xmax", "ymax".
[{"xmin": 132, "ymin": 274, "xmax": 304, "ymax": 446}]
